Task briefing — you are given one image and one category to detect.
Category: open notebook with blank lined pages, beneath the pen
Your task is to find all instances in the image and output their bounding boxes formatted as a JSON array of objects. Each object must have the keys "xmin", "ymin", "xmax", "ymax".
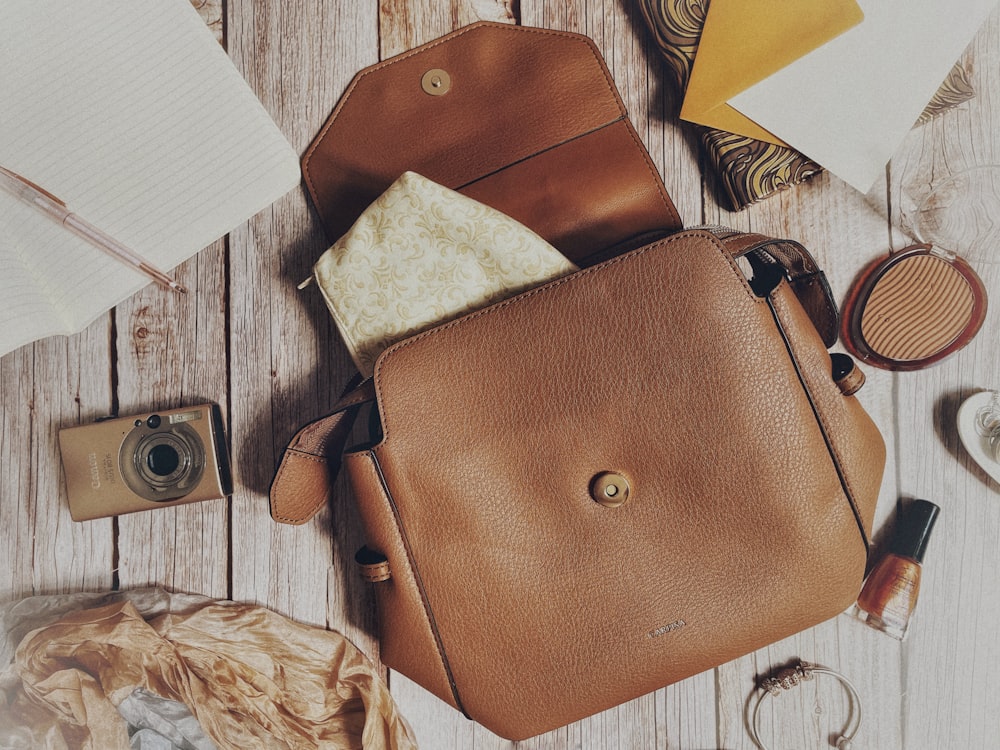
[{"xmin": 0, "ymin": 0, "xmax": 299, "ymax": 355}]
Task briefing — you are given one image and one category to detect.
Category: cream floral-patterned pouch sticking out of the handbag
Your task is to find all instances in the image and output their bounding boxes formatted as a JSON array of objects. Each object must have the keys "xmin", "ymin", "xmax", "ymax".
[{"xmin": 313, "ymin": 172, "xmax": 576, "ymax": 377}]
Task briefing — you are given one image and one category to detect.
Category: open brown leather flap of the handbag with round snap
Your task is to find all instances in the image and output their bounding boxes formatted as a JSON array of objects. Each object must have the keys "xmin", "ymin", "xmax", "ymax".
[{"xmin": 302, "ymin": 22, "xmax": 680, "ymax": 257}]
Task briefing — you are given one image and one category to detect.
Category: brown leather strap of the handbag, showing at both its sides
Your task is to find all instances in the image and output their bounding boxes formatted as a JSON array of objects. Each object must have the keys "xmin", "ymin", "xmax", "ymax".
[{"xmin": 270, "ymin": 232, "xmax": 839, "ymax": 525}]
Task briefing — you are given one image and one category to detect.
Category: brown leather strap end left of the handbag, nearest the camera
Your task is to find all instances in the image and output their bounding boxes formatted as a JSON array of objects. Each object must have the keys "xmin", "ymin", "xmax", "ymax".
[{"xmin": 270, "ymin": 376, "xmax": 375, "ymax": 525}]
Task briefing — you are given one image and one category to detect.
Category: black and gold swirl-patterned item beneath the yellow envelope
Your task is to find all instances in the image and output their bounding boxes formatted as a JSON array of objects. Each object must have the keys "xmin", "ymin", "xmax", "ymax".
[{"xmin": 639, "ymin": 0, "xmax": 973, "ymax": 211}]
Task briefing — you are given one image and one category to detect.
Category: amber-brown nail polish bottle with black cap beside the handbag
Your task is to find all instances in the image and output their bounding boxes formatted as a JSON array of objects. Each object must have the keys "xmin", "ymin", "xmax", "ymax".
[{"xmin": 854, "ymin": 500, "xmax": 940, "ymax": 640}]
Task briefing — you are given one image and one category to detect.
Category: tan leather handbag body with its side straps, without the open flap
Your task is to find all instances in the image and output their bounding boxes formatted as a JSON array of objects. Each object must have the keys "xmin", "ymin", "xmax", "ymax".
[{"xmin": 272, "ymin": 230, "xmax": 885, "ymax": 739}]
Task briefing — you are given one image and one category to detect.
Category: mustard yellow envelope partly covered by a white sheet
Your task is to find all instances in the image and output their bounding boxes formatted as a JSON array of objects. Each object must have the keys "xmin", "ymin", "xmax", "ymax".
[{"xmin": 681, "ymin": 0, "xmax": 864, "ymax": 146}]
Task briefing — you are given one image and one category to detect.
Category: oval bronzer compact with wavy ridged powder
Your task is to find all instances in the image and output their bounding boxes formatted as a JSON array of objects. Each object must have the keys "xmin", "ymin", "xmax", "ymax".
[{"xmin": 842, "ymin": 244, "xmax": 986, "ymax": 370}]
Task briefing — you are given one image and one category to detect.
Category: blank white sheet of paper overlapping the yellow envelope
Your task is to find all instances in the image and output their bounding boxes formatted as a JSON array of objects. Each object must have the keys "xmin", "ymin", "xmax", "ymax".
[{"xmin": 729, "ymin": 0, "xmax": 997, "ymax": 192}]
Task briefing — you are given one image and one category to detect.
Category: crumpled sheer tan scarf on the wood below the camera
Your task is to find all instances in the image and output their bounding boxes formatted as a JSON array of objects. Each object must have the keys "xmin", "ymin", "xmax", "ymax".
[{"xmin": 0, "ymin": 590, "xmax": 416, "ymax": 750}]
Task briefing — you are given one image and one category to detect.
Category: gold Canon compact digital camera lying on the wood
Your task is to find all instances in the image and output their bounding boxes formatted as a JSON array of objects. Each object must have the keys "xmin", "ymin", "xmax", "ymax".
[{"xmin": 59, "ymin": 404, "xmax": 233, "ymax": 521}]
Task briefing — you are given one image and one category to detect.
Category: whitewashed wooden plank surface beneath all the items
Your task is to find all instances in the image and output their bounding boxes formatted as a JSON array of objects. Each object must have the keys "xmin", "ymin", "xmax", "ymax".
[{"xmin": 0, "ymin": 0, "xmax": 1000, "ymax": 750}]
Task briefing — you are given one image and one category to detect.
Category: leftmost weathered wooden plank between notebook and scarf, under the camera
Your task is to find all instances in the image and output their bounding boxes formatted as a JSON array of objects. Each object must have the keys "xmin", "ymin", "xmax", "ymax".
[{"xmin": 0, "ymin": 326, "xmax": 115, "ymax": 601}]
